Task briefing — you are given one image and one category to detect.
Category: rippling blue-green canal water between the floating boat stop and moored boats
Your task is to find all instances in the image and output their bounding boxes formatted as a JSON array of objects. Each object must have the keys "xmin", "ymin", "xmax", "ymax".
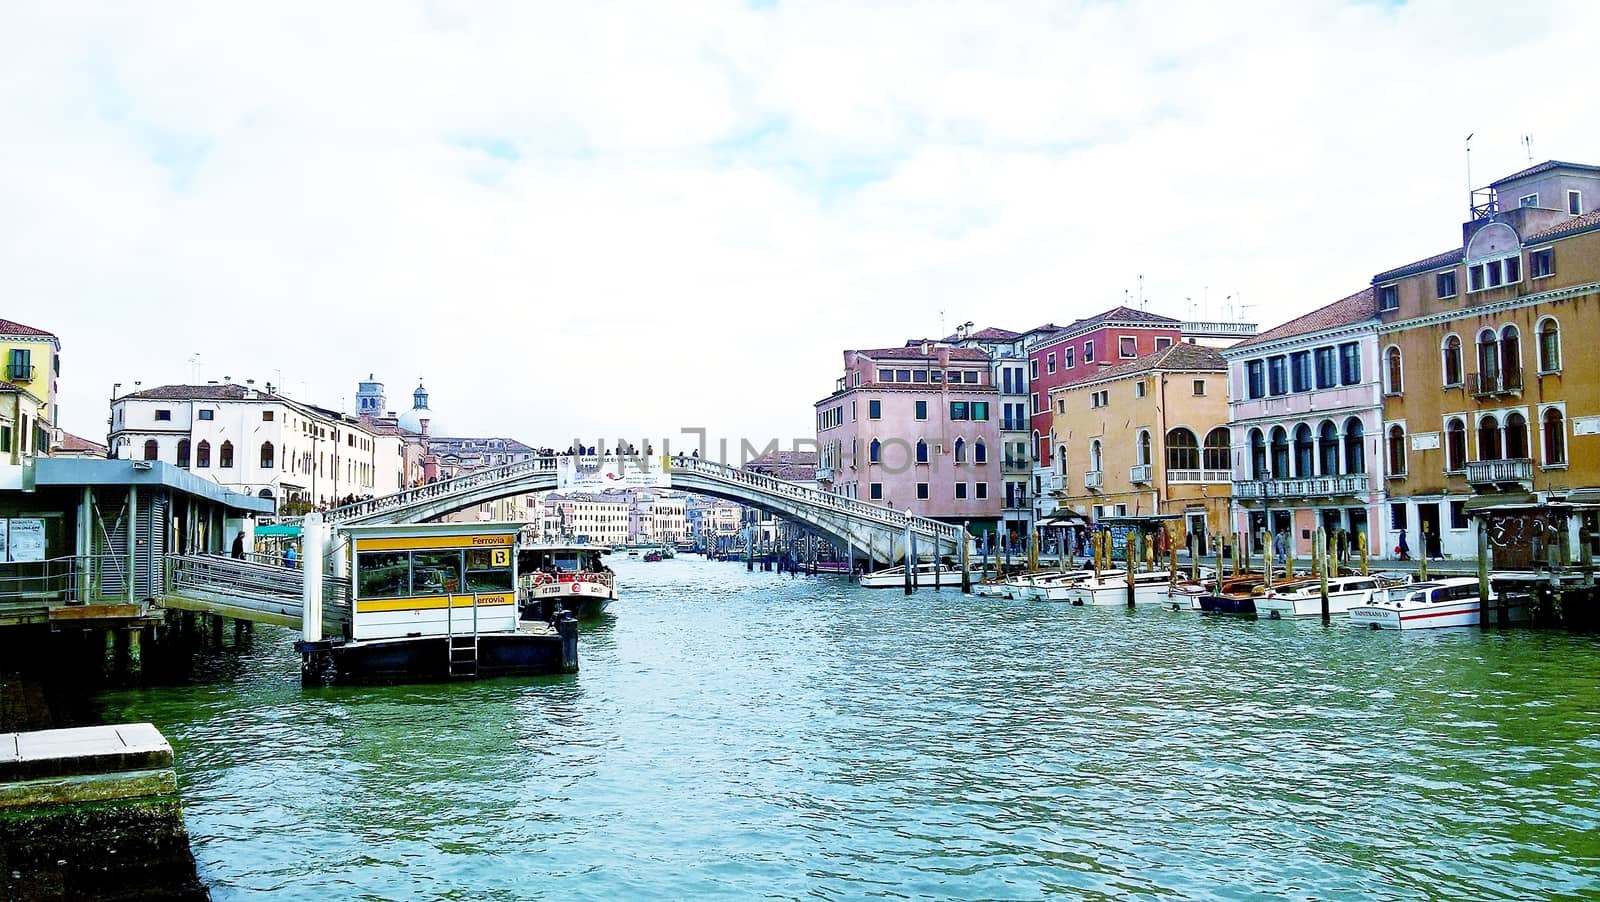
[{"xmin": 104, "ymin": 558, "xmax": 1600, "ymax": 899}]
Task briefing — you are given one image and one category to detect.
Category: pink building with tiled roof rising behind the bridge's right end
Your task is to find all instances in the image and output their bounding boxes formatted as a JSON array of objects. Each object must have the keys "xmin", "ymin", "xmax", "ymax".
[{"xmin": 816, "ymin": 342, "xmax": 1003, "ymax": 533}]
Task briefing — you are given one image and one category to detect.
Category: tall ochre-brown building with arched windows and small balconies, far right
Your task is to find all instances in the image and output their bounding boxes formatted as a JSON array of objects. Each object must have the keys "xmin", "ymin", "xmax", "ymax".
[{"xmin": 1373, "ymin": 162, "xmax": 1600, "ymax": 558}]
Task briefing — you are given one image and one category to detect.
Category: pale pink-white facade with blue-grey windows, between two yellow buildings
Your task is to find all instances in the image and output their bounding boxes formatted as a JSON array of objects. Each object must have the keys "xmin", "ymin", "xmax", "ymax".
[{"xmin": 1222, "ymin": 288, "xmax": 1387, "ymax": 557}]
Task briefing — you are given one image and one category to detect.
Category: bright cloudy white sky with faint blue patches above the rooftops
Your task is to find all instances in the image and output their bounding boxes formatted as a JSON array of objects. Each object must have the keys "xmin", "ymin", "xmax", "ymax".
[{"xmin": 0, "ymin": 0, "xmax": 1600, "ymax": 448}]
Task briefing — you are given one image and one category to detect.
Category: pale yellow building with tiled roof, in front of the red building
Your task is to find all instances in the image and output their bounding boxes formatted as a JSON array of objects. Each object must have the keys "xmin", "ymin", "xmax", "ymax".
[{"xmin": 1050, "ymin": 344, "xmax": 1232, "ymax": 544}]
